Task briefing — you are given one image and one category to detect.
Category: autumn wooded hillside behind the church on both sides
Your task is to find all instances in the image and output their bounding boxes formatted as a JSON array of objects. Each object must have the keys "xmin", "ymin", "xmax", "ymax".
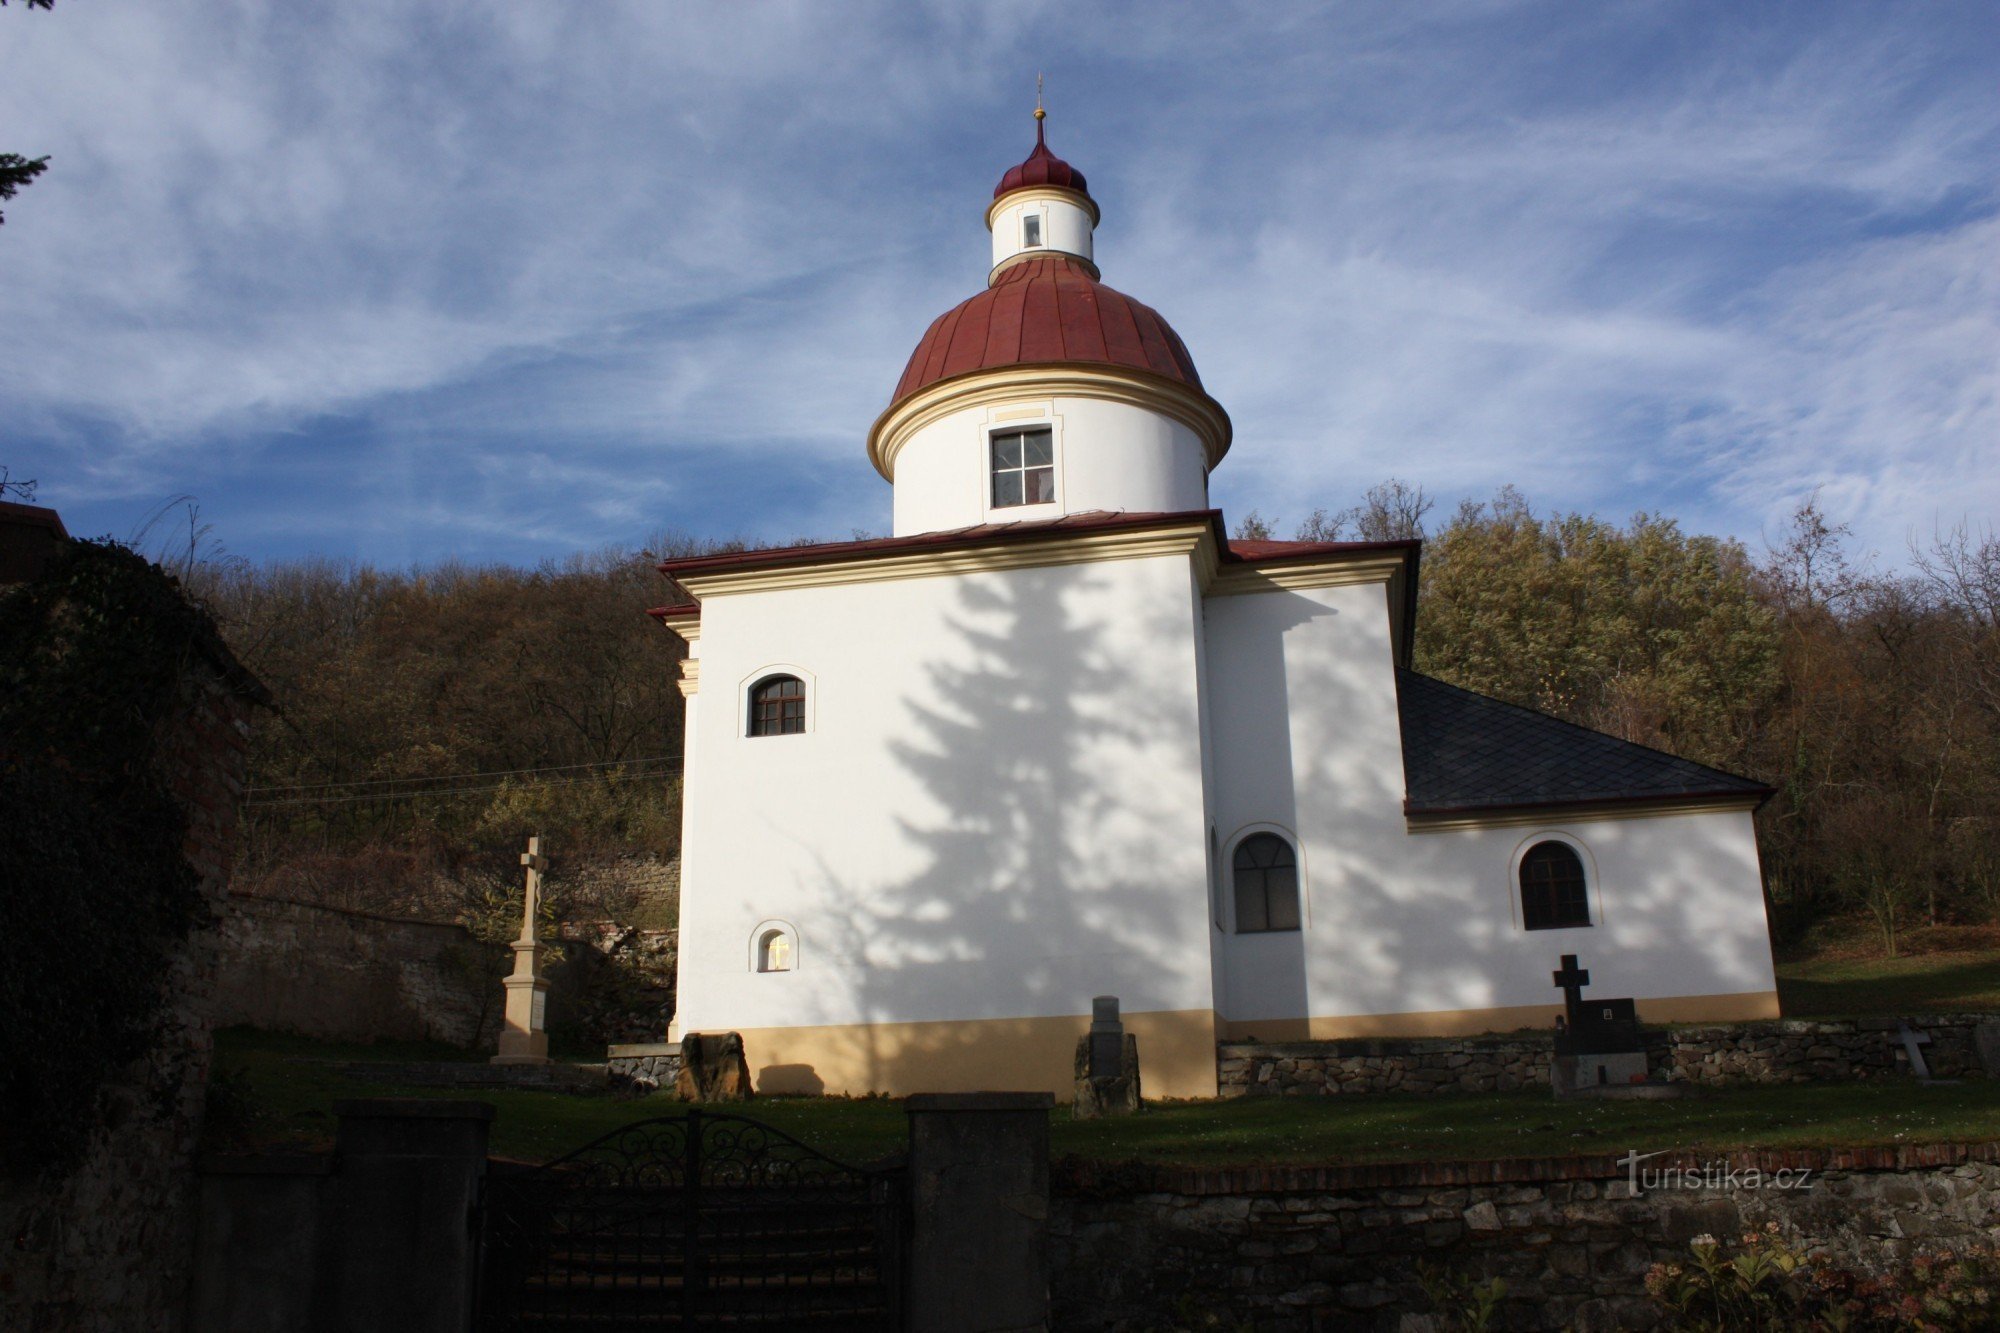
[{"xmin": 190, "ymin": 492, "xmax": 2000, "ymax": 949}]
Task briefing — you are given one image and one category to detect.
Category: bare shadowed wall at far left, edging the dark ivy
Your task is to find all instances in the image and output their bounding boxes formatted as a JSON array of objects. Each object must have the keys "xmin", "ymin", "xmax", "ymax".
[{"xmin": 0, "ymin": 667, "xmax": 250, "ymax": 1333}]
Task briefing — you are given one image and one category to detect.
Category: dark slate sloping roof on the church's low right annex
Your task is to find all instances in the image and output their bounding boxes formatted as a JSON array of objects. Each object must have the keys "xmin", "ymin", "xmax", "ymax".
[{"xmin": 1396, "ymin": 671, "xmax": 1770, "ymax": 815}]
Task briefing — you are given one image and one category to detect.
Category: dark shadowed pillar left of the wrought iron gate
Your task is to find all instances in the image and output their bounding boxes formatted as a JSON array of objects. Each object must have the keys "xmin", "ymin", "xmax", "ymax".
[{"xmin": 328, "ymin": 1099, "xmax": 494, "ymax": 1333}]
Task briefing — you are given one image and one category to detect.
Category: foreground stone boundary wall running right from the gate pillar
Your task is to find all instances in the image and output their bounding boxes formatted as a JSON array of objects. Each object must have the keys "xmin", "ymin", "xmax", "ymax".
[{"xmin": 1050, "ymin": 1143, "xmax": 2000, "ymax": 1333}]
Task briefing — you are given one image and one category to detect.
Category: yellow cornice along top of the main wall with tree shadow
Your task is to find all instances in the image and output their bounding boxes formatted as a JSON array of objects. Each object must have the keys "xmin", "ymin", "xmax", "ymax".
[{"xmin": 674, "ymin": 518, "xmax": 1214, "ymax": 598}]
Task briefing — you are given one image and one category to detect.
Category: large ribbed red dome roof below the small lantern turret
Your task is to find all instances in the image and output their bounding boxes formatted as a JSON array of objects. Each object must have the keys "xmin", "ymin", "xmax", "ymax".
[{"xmin": 890, "ymin": 254, "xmax": 1202, "ymax": 404}]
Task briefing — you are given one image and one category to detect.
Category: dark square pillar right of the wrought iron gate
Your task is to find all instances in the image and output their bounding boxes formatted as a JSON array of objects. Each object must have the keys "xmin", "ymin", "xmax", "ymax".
[{"xmin": 904, "ymin": 1093, "xmax": 1056, "ymax": 1333}]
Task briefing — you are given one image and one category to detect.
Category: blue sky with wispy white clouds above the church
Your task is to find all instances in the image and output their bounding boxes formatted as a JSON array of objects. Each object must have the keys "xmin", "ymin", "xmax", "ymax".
[{"xmin": 0, "ymin": 0, "xmax": 2000, "ymax": 564}]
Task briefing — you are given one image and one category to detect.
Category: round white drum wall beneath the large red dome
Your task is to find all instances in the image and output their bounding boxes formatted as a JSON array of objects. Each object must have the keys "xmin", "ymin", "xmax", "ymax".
[{"xmin": 894, "ymin": 392, "xmax": 1208, "ymax": 536}]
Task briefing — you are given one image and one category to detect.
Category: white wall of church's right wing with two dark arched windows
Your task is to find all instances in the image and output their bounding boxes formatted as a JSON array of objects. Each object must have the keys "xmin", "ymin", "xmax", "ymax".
[{"xmin": 1208, "ymin": 584, "xmax": 1776, "ymax": 1041}]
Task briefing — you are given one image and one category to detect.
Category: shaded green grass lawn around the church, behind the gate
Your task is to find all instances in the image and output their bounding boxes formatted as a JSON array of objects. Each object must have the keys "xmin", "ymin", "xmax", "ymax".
[{"xmin": 216, "ymin": 1029, "xmax": 2000, "ymax": 1165}]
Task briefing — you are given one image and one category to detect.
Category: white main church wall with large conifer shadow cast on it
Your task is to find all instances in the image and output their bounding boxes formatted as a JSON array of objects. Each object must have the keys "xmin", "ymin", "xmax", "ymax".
[{"xmin": 678, "ymin": 554, "xmax": 1214, "ymax": 1095}]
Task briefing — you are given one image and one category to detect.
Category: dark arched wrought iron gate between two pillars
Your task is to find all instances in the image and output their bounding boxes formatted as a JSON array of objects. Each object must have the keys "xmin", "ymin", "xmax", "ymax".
[{"xmin": 478, "ymin": 1111, "xmax": 904, "ymax": 1333}]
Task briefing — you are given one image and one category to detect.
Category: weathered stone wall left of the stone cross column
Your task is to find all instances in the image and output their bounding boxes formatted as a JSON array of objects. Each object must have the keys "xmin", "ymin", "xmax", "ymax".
[{"xmin": 216, "ymin": 899, "xmax": 504, "ymax": 1047}]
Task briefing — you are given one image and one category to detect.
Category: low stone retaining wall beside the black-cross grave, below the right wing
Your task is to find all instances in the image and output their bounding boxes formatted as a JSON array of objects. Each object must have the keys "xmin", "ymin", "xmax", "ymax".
[{"xmin": 1220, "ymin": 1015, "xmax": 2000, "ymax": 1097}]
